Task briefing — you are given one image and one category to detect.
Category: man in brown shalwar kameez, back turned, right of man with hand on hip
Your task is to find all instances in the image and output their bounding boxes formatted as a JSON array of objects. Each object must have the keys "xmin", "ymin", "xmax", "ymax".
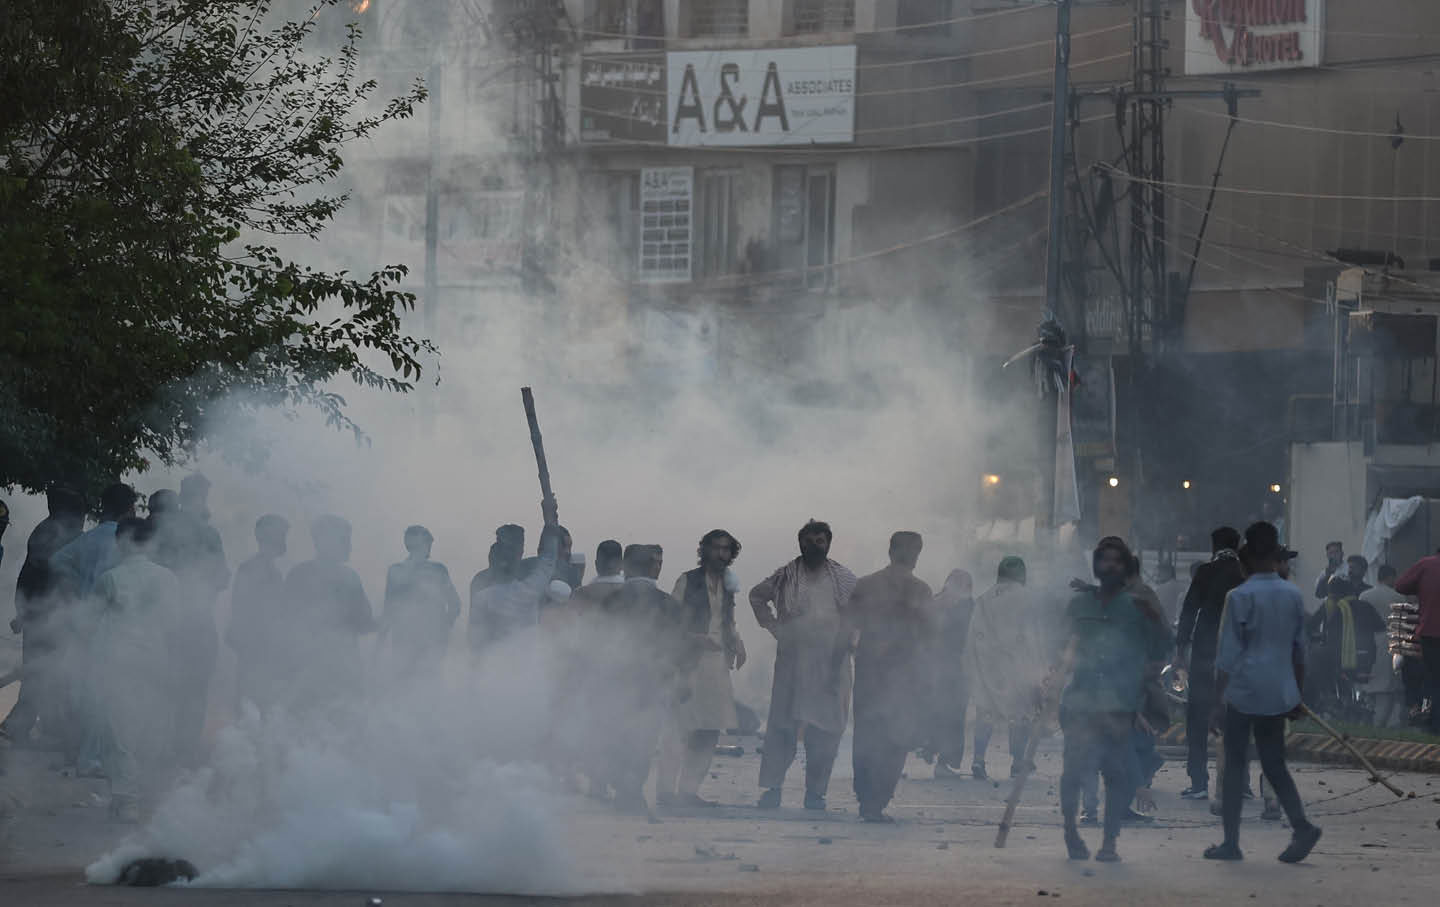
[{"xmin": 845, "ymin": 531, "xmax": 933, "ymax": 823}]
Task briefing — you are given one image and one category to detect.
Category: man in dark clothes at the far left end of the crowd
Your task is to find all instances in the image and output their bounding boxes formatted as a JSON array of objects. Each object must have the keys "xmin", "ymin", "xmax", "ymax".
[{"xmin": 0, "ymin": 487, "xmax": 85, "ymax": 743}]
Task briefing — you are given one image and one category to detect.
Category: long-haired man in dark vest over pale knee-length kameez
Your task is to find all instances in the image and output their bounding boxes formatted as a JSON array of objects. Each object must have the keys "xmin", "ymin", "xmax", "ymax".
[{"xmin": 655, "ymin": 530, "xmax": 744, "ymax": 806}]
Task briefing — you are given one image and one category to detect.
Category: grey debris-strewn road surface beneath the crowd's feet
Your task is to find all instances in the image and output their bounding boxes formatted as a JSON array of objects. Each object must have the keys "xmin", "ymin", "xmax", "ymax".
[{"xmin": 0, "ymin": 741, "xmax": 1440, "ymax": 907}]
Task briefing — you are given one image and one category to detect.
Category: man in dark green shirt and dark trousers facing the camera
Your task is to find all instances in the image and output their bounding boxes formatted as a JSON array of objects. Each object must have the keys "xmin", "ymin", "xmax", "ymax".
[{"xmin": 1060, "ymin": 536, "xmax": 1171, "ymax": 862}]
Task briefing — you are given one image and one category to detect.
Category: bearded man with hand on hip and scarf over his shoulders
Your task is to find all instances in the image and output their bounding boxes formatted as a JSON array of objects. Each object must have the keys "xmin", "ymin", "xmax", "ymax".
[{"xmin": 750, "ymin": 520, "xmax": 855, "ymax": 811}]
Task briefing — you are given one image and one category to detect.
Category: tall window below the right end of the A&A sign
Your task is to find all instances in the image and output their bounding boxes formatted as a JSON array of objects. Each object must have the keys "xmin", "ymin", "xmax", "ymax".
[{"xmin": 773, "ymin": 167, "xmax": 835, "ymax": 286}]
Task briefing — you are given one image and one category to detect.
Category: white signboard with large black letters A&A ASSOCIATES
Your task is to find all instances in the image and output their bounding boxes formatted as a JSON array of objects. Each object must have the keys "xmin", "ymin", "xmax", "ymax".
[{"xmin": 665, "ymin": 45, "xmax": 855, "ymax": 145}]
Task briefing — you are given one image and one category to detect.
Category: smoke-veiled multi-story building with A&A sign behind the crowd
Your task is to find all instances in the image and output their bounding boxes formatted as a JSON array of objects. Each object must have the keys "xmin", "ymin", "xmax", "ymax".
[{"xmin": 324, "ymin": 0, "xmax": 1440, "ymax": 564}]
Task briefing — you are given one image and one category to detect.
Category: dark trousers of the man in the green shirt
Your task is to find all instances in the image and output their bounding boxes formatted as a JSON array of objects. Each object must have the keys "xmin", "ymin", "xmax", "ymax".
[{"xmin": 1060, "ymin": 711, "xmax": 1135, "ymax": 839}]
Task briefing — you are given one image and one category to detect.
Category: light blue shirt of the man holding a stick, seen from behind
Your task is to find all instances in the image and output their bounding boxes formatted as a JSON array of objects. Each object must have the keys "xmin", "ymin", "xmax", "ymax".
[{"xmin": 1215, "ymin": 573, "xmax": 1305, "ymax": 716}]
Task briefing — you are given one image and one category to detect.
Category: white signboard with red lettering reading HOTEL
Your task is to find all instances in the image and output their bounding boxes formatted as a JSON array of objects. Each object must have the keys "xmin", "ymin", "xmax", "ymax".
[{"xmin": 1185, "ymin": 0, "xmax": 1325, "ymax": 75}]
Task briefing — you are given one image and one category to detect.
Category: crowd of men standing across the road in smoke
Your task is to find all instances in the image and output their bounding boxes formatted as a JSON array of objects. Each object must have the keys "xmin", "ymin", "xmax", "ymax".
[{"xmin": 11, "ymin": 475, "xmax": 1440, "ymax": 861}]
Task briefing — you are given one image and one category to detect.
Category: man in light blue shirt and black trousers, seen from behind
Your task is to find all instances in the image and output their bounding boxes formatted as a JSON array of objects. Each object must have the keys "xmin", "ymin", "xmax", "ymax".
[{"xmin": 1205, "ymin": 523, "xmax": 1320, "ymax": 862}]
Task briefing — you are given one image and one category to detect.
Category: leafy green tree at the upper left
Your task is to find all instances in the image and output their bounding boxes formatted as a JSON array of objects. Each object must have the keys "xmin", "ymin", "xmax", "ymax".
[{"xmin": 0, "ymin": 0, "xmax": 431, "ymax": 491}]
